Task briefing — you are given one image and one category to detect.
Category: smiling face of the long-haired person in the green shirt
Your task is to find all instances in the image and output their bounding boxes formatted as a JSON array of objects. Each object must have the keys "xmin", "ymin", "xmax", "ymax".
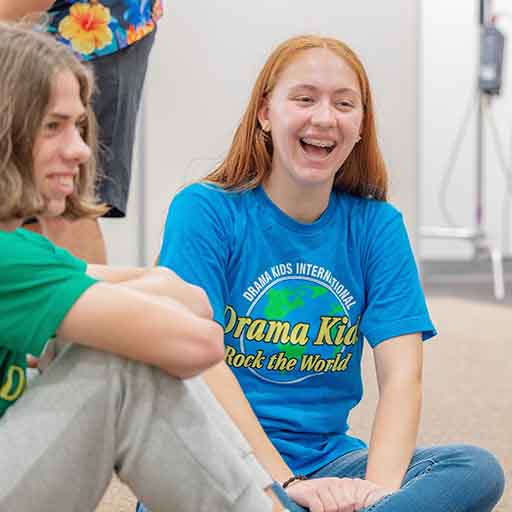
[{"xmin": 32, "ymin": 70, "xmax": 91, "ymax": 216}]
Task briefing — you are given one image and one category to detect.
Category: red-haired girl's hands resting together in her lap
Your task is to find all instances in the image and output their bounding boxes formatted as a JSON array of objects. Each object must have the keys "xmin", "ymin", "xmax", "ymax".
[{"xmin": 286, "ymin": 478, "xmax": 389, "ymax": 512}]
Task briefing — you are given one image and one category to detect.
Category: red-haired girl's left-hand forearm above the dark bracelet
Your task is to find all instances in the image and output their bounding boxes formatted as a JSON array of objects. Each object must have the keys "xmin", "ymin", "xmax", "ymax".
[{"xmin": 203, "ymin": 362, "xmax": 293, "ymax": 483}]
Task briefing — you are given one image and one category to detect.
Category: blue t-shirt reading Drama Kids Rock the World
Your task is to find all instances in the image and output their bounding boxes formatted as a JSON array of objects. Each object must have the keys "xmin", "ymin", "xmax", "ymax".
[{"xmin": 160, "ymin": 184, "xmax": 435, "ymax": 473}]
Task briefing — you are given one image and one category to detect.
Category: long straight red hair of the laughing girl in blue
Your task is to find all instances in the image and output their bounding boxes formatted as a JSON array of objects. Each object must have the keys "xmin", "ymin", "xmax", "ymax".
[{"xmin": 204, "ymin": 35, "xmax": 388, "ymax": 201}]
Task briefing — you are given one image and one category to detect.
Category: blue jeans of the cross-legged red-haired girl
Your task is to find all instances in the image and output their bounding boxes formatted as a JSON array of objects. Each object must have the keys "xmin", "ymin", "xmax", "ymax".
[{"xmin": 137, "ymin": 444, "xmax": 505, "ymax": 512}]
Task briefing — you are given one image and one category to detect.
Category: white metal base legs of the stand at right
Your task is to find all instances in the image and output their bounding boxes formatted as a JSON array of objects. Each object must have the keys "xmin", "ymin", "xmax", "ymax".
[{"xmin": 420, "ymin": 227, "xmax": 505, "ymax": 300}]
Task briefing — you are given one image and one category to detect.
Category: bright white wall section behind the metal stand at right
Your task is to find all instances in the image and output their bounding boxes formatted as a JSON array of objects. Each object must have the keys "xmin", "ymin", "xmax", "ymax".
[{"xmin": 420, "ymin": 0, "xmax": 512, "ymax": 259}]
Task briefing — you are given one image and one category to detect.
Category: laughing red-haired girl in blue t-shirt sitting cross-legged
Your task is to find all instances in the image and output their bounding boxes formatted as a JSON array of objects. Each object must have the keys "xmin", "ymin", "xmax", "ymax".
[{"xmin": 150, "ymin": 36, "xmax": 504, "ymax": 512}]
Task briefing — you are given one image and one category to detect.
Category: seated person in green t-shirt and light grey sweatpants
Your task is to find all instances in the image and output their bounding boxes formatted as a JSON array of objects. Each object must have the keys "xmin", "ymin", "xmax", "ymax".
[{"xmin": 0, "ymin": 23, "xmax": 292, "ymax": 512}]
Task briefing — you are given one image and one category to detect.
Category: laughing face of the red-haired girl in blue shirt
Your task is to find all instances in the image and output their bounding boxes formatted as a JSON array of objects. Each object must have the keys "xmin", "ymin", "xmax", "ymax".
[{"xmin": 258, "ymin": 48, "xmax": 364, "ymax": 194}]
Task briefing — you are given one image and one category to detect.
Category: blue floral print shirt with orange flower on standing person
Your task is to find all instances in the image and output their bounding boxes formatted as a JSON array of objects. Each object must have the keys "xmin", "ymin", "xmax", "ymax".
[{"xmin": 47, "ymin": 0, "xmax": 163, "ymax": 61}]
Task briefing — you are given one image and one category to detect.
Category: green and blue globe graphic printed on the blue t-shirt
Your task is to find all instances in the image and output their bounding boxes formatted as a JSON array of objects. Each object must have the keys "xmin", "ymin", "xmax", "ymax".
[{"xmin": 240, "ymin": 277, "xmax": 350, "ymax": 384}]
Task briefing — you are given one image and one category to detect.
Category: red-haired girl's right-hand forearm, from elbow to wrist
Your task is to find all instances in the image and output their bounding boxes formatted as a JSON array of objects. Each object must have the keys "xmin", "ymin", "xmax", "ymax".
[{"xmin": 366, "ymin": 378, "xmax": 421, "ymax": 490}]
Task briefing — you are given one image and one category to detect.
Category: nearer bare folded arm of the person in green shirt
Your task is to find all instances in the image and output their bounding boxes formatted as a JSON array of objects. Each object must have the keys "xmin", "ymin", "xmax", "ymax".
[{"xmin": 58, "ymin": 283, "xmax": 223, "ymax": 378}]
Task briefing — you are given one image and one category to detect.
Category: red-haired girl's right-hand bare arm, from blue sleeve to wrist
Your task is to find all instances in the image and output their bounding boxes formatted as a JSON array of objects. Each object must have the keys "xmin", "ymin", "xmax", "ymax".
[{"xmin": 366, "ymin": 334, "xmax": 422, "ymax": 491}]
